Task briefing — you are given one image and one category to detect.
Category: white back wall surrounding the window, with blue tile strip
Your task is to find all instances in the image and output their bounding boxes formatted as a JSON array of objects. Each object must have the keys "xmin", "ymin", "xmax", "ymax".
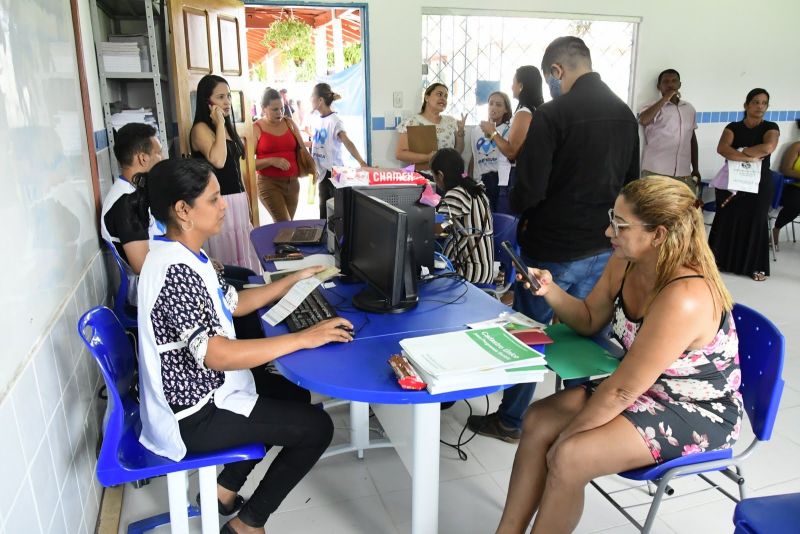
[{"xmin": 296, "ymin": 0, "xmax": 800, "ymax": 177}]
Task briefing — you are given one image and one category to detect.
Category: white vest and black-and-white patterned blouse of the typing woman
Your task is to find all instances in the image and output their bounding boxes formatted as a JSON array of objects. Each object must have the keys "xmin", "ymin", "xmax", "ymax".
[{"xmin": 138, "ymin": 236, "xmax": 258, "ymax": 461}]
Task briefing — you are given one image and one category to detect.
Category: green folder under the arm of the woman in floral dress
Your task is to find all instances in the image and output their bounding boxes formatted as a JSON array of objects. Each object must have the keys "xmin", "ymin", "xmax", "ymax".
[{"xmin": 545, "ymin": 323, "xmax": 619, "ymax": 380}]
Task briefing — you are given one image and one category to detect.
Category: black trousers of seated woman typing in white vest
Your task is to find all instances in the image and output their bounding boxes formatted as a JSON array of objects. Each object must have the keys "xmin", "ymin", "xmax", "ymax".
[{"xmin": 179, "ymin": 368, "xmax": 333, "ymax": 528}]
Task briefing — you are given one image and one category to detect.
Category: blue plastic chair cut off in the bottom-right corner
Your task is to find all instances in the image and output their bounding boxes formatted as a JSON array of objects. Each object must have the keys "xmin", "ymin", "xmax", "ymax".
[{"xmin": 733, "ymin": 493, "xmax": 800, "ymax": 534}]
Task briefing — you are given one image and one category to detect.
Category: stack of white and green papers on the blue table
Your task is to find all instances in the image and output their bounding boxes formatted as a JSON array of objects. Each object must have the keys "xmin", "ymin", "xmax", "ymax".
[{"xmin": 400, "ymin": 326, "xmax": 547, "ymax": 394}]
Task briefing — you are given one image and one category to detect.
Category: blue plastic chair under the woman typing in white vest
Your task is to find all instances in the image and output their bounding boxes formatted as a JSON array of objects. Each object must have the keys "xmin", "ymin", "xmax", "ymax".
[{"xmin": 78, "ymin": 306, "xmax": 266, "ymax": 534}]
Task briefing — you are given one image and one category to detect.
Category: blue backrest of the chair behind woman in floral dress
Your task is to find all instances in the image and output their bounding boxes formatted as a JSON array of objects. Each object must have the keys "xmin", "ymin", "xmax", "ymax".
[{"xmin": 733, "ymin": 304, "xmax": 785, "ymax": 441}]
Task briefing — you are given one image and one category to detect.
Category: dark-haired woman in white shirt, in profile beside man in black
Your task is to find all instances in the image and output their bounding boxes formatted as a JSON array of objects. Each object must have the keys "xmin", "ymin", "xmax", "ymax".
[{"xmin": 480, "ymin": 65, "xmax": 544, "ymax": 213}]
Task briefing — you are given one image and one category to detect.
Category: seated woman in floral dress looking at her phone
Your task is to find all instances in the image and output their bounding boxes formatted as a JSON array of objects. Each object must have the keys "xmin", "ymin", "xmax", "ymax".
[{"xmin": 497, "ymin": 176, "xmax": 742, "ymax": 533}]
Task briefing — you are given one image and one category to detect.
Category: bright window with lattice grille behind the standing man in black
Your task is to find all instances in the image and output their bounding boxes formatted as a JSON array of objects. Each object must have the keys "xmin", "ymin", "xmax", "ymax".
[{"xmin": 422, "ymin": 13, "xmax": 638, "ymax": 123}]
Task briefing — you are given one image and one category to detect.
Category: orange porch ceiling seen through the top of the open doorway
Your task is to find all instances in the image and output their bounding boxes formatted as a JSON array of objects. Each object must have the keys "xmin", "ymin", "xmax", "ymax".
[{"xmin": 245, "ymin": 6, "xmax": 361, "ymax": 65}]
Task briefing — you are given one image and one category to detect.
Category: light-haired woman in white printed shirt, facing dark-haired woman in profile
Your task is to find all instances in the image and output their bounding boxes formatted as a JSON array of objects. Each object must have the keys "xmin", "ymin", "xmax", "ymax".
[{"xmin": 468, "ymin": 91, "xmax": 511, "ymax": 213}]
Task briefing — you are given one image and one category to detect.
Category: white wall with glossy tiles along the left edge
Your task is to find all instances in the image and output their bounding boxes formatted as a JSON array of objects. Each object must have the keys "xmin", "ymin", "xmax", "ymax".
[{"xmin": 0, "ymin": 0, "xmax": 107, "ymax": 534}]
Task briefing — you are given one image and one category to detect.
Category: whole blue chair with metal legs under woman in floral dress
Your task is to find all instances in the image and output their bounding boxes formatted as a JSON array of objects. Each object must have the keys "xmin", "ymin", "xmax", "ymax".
[{"xmin": 592, "ymin": 304, "xmax": 784, "ymax": 532}]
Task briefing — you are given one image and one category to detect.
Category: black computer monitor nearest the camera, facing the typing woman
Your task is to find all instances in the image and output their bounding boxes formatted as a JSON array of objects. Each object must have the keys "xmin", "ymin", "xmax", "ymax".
[{"xmin": 349, "ymin": 191, "xmax": 418, "ymax": 313}]
